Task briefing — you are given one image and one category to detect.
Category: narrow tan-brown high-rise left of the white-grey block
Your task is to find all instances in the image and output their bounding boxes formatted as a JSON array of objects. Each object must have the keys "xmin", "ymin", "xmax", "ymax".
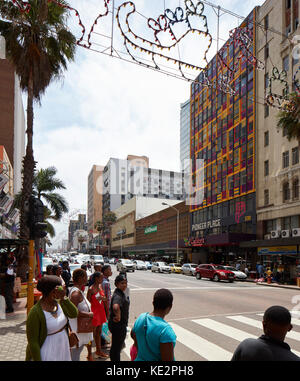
[{"xmin": 87, "ymin": 165, "xmax": 104, "ymax": 234}]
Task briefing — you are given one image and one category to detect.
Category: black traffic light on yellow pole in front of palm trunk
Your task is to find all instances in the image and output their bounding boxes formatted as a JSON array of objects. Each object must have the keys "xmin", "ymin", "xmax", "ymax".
[{"xmin": 28, "ymin": 196, "xmax": 47, "ymax": 239}]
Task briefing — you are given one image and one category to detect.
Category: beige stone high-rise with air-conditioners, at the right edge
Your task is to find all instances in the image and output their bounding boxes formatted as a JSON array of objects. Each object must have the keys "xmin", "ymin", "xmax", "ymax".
[{"xmin": 244, "ymin": 0, "xmax": 300, "ymax": 283}]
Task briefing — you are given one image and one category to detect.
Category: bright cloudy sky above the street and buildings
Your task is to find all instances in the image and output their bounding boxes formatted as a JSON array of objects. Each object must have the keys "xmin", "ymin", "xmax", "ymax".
[{"xmin": 28, "ymin": 0, "xmax": 264, "ymax": 248}]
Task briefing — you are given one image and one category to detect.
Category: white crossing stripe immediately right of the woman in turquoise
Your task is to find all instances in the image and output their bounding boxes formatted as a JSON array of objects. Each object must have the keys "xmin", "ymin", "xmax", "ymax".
[{"xmin": 171, "ymin": 323, "xmax": 232, "ymax": 361}]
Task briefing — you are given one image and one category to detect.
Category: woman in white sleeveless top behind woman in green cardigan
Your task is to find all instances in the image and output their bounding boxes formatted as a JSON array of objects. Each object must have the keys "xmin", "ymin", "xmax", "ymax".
[{"xmin": 69, "ymin": 269, "xmax": 94, "ymax": 361}]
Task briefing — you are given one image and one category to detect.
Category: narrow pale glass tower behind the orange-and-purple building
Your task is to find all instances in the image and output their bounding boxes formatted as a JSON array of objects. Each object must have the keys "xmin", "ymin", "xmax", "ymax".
[{"xmin": 180, "ymin": 100, "xmax": 191, "ymax": 171}]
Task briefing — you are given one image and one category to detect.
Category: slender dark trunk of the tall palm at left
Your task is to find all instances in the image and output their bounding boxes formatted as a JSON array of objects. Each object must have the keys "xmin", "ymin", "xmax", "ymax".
[{"xmin": 19, "ymin": 70, "xmax": 35, "ymax": 280}]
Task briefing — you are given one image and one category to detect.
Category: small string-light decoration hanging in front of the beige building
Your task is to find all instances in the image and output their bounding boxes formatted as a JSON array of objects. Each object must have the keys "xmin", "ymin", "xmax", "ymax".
[{"xmin": 266, "ymin": 67, "xmax": 295, "ymax": 112}]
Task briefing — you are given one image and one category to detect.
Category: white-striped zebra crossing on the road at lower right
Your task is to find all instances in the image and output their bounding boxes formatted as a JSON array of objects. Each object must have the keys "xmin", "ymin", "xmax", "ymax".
[{"xmin": 121, "ymin": 311, "xmax": 300, "ymax": 361}]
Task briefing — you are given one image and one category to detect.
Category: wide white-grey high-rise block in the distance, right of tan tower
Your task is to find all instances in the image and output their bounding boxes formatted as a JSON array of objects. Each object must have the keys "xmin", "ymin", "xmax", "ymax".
[{"xmin": 103, "ymin": 156, "xmax": 184, "ymax": 214}]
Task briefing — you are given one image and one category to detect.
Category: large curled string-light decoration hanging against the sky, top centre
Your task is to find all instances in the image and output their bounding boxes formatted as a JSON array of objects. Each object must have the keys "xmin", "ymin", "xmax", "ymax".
[{"xmin": 116, "ymin": 0, "xmax": 212, "ymax": 80}]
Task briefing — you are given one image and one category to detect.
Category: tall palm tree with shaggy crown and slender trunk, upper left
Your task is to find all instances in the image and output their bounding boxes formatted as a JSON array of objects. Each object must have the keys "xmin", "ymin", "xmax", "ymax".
[{"xmin": 0, "ymin": 0, "xmax": 76, "ymax": 239}]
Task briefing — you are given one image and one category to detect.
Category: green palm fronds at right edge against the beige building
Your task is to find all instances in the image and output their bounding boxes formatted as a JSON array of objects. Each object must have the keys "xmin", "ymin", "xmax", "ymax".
[{"xmin": 277, "ymin": 93, "xmax": 300, "ymax": 146}]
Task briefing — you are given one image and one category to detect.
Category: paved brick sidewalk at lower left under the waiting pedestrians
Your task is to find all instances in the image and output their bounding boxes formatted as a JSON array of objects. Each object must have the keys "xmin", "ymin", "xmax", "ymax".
[{"xmin": 0, "ymin": 298, "xmax": 110, "ymax": 362}]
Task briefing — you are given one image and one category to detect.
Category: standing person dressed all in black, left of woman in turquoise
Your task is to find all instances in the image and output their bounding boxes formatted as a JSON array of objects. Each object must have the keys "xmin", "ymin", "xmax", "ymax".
[{"xmin": 108, "ymin": 275, "xmax": 129, "ymax": 361}]
